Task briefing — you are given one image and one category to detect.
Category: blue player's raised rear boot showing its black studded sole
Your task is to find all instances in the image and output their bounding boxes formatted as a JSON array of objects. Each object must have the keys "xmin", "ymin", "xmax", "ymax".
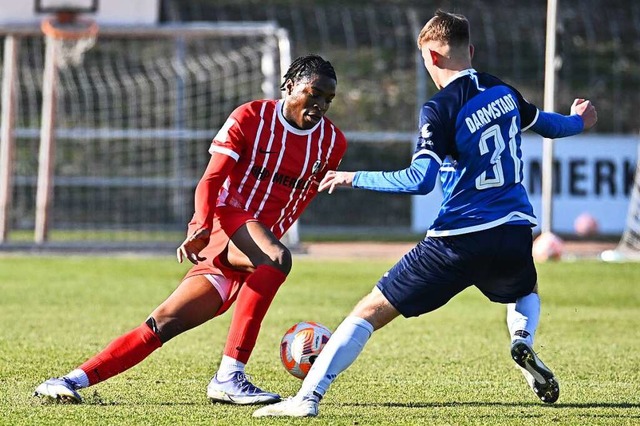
[{"xmin": 511, "ymin": 339, "xmax": 560, "ymax": 404}]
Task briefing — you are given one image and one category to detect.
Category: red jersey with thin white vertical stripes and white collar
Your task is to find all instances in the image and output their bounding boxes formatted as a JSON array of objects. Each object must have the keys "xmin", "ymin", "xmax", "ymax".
[{"xmin": 209, "ymin": 100, "xmax": 347, "ymax": 238}]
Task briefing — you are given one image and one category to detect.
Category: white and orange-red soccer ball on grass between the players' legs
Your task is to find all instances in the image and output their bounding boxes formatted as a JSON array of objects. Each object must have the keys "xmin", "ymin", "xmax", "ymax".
[{"xmin": 280, "ymin": 321, "xmax": 331, "ymax": 379}]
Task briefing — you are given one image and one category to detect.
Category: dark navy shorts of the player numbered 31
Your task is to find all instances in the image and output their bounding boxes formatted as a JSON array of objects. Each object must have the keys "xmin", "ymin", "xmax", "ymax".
[{"xmin": 377, "ymin": 225, "xmax": 538, "ymax": 317}]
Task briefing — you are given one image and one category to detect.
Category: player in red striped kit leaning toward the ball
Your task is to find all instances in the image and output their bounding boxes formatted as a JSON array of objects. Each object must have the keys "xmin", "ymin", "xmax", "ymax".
[{"xmin": 35, "ymin": 55, "xmax": 346, "ymax": 404}]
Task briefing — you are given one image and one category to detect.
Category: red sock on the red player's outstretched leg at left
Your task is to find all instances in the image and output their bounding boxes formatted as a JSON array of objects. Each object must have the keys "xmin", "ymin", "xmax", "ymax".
[{"xmin": 78, "ymin": 323, "xmax": 162, "ymax": 385}]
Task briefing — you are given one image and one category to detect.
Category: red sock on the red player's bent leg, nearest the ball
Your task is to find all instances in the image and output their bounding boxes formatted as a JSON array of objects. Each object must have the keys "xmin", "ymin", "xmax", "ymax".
[{"xmin": 224, "ymin": 265, "xmax": 287, "ymax": 364}]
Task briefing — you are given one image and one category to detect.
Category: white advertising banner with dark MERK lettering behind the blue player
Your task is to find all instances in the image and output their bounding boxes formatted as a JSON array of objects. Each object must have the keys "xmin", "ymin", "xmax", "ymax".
[{"xmin": 412, "ymin": 134, "xmax": 640, "ymax": 235}]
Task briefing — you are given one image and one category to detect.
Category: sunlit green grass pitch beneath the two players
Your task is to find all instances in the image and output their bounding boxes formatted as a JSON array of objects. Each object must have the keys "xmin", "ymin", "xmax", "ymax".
[{"xmin": 0, "ymin": 256, "xmax": 640, "ymax": 425}]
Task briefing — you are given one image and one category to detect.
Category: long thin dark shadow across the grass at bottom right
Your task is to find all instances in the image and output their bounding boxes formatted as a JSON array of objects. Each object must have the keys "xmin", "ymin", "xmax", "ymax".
[{"xmin": 337, "ymin": 401, "xmax": 640, "ymax": 408}]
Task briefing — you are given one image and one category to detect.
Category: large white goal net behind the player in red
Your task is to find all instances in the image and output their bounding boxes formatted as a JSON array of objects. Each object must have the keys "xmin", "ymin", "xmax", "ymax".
[{"xmin": 4, "ymin": 22, "xmax": 298, "ymax": 247}]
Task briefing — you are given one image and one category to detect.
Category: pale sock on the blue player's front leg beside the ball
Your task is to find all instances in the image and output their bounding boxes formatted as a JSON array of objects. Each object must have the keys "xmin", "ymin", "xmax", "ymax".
[{"xmin": 297, "ymin": 316, "xmax": 373, "ymax": 400}]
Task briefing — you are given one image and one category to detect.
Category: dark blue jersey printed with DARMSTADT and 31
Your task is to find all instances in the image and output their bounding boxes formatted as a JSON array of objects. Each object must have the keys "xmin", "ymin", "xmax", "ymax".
[{"xmin": 414, "ymin": 69, "xmax": 538, "ymax": 236}]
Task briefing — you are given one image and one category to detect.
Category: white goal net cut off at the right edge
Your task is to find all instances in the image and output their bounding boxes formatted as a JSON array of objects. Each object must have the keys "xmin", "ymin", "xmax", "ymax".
[{"xmin": 601, "ymin": 146, "xmax": 640, "ymax": 261}]
